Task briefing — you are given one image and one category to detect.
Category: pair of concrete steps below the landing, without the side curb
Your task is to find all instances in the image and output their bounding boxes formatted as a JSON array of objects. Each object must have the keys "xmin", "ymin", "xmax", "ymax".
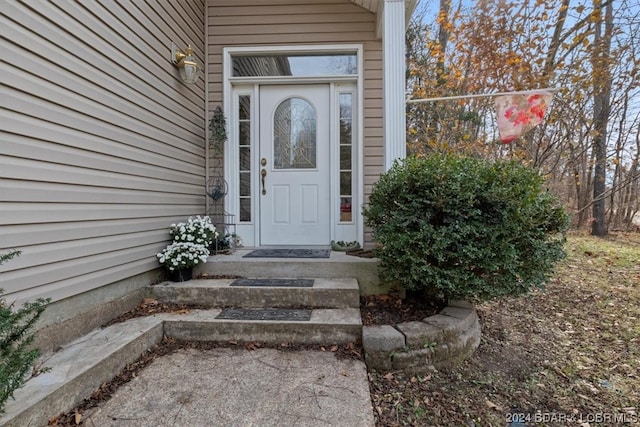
[{"xmin": 149, "ymin": 278, "xmax": 362, "ymax": 344}]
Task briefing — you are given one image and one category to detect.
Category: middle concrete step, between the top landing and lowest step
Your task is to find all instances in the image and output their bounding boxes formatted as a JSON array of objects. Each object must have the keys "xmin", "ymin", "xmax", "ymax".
[{"xmin": 149, "ymin": 278, "xmax": 360, "ymax": 308}]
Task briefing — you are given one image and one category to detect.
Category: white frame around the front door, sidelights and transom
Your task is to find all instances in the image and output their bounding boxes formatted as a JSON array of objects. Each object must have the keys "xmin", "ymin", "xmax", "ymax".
[{"xmin": 223, "ymin": 45, "xmax": 364, "ymax": 247}]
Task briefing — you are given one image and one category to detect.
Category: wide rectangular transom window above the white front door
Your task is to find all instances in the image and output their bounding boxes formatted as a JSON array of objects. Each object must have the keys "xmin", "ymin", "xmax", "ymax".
[{"xmin": 233, "ymin": 53, "xmax": 358, "ymax": 77}]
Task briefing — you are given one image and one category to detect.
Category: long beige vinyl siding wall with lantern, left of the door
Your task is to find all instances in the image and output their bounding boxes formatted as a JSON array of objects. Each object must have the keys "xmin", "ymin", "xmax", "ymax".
[{"xmin": 0, "ymin": 0, "xmax": 206, "ymax": 301}]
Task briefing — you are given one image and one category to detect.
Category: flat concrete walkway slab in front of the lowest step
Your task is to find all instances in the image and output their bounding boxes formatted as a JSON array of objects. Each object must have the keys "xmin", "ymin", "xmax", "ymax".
[{"xmin": 83, "ymin": 348, "xmax": 374, "ymax": 427}]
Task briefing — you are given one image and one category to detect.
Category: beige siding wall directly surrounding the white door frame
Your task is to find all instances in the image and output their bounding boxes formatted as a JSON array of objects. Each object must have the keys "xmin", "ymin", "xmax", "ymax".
[{"xmin": 207, "ymin": 0, "xmax": 384, "ymax": 246}]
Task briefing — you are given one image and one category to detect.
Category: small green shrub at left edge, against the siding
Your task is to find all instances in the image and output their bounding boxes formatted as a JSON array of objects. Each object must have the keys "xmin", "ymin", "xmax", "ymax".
[{"xmin": 0, "ymin": 251, "xmax": 49, "ymax": 414}]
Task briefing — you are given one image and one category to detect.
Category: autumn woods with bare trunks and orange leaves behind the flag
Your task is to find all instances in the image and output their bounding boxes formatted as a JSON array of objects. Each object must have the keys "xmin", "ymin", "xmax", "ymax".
[{"xmin": 407, "ymin": 0, "xmax": 640, "ymax": 231}]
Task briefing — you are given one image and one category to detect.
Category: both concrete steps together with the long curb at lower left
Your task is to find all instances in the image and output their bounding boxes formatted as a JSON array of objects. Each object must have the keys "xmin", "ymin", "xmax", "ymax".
[{"xmin": 0, "ymin": 279, "xmax": 362, "ymax": 427}]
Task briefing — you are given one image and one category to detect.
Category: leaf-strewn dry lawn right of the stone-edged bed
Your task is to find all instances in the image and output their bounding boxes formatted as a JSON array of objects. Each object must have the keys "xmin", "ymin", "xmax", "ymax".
[{"xmin": 370, "ymin": 234, "xmax": 640, "ymax": 427}]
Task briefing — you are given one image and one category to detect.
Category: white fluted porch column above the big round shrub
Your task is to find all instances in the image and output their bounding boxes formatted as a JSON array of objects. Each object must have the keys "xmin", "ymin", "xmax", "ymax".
[{"xmin": 382, "ymin": 0, "xmax": 407, "ymax": 171}]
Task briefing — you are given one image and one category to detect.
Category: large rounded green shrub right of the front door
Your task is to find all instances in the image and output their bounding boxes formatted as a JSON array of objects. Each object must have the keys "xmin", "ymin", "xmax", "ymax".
[{"xmin": 364, "ymin": 154, "xmax": 569, "ymax": 300}]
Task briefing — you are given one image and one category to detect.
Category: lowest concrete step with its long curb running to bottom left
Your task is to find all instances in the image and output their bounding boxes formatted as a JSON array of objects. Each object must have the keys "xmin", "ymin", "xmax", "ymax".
[{"xmin": 0, "ymin": 308, "xmax": 362, "ymax": 427}]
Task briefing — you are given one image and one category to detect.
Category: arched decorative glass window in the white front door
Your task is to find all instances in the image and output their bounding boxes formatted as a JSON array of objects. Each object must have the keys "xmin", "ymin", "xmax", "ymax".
[{"xmin": 273, "ymin": 98, "xmax": 317, "ymax": 169}]
